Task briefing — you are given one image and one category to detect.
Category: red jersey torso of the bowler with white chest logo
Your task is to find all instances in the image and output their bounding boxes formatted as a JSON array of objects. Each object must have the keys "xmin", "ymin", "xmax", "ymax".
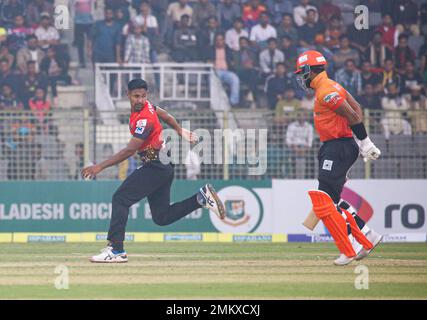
[{"xmin": 129, "ymin": 100, "xmax": 163, "ymax": 152}]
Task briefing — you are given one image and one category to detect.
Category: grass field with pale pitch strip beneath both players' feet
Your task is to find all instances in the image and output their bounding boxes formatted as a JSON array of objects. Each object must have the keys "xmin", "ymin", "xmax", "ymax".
[{"xmin": 0, "ymin": 243, "xmax": 427, "ymax": 299}]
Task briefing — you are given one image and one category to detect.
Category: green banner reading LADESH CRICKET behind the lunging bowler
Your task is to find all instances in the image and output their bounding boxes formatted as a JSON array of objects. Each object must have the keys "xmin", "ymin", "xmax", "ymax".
[{"xmin": 0, "ymin": 180, "xmax": 271, "ymax": 233}]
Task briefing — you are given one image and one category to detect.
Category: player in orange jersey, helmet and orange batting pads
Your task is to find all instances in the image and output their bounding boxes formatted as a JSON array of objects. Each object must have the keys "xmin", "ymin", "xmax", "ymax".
[{"xmin": 295, "ymin": 51, "xmax": 382, "ymax": 266}]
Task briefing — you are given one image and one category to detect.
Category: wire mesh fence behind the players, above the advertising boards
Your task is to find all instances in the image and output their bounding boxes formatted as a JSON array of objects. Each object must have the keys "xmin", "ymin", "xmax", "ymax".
[{"xmin": 0, "ymin": 108, "xmax": 427, "ymax": 181}]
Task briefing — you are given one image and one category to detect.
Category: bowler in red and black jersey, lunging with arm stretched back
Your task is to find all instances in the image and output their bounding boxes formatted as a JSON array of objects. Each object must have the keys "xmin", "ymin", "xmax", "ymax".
[{"xmin": 82, "ymin": 79, "xmax": 225, "ymax": 263}]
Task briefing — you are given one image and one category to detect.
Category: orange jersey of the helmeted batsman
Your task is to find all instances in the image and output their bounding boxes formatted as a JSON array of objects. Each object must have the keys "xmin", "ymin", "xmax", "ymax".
[{"xmin": 310, "ymin": 71, "xmax": 353, "ymax": 142}]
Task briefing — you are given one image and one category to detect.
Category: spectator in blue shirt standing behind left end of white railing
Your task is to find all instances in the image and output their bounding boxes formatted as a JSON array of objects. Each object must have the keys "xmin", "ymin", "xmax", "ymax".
[{"xmin": 89, "ymin": 8, "xmax": 122, "ymax": 63}]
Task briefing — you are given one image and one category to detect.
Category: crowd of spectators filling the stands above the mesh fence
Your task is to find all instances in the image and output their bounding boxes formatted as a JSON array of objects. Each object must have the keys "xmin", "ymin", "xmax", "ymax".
[{"xmin": 0, "ymin": 0, "xmax": 427, "ymax": 180}]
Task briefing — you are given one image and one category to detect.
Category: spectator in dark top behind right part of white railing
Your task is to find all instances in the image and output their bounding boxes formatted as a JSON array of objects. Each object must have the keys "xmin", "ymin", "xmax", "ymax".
[{"xmin": 172, "ymin": 14, "xmax": 198, "ymax": 62}]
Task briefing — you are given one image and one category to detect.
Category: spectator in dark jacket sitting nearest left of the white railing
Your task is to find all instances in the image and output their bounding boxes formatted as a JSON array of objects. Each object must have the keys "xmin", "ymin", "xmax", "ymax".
[{"xmin": 40, "ymin": 47, "xmax": 71, "ymax": 105}]
